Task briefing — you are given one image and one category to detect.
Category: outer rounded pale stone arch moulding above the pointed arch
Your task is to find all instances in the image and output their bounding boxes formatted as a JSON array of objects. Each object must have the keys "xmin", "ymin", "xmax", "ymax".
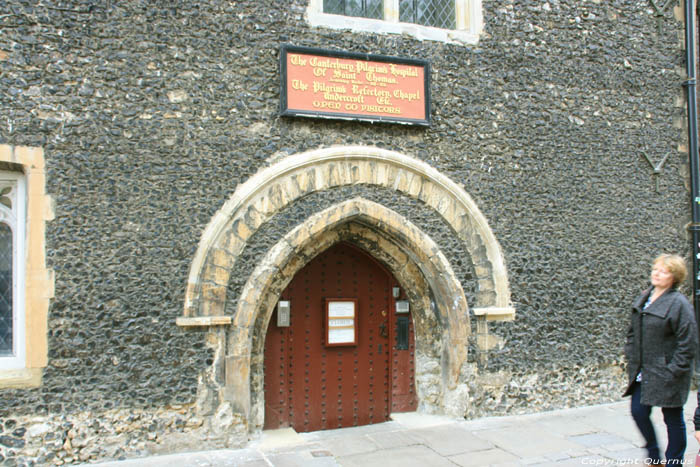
[{"xmin": 177, "ymin": 146, "xmax": 515, "ymax": 326}]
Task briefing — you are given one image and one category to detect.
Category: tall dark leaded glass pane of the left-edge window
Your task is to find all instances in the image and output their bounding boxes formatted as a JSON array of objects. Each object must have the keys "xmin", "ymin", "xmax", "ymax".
[{"xmin": 0, "ymin": 223, "xmax": 14, "ymax": 357}]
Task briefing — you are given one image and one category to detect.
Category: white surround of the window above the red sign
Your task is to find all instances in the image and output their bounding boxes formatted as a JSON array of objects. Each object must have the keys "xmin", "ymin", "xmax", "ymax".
[{"xmin": 306, "ymin": 0, "xmax": 484, "ymax": 44}]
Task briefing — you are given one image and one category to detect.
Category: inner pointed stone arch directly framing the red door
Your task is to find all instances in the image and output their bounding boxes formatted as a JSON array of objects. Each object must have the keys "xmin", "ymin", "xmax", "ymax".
[{"xmin": 230, "ymin": 198, "xmax": 471, "ymax": 427}]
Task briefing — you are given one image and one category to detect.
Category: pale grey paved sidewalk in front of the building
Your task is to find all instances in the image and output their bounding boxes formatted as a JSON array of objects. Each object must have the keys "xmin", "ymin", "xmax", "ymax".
[{"xmin": 92, "ymin": 393, "xmax": 698, "ymax": 467}]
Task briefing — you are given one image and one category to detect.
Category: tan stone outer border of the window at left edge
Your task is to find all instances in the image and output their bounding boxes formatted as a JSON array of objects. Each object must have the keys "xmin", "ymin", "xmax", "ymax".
[{"xmin": 0, "ymin": 144, "xmax": 54, "ymax": 388}]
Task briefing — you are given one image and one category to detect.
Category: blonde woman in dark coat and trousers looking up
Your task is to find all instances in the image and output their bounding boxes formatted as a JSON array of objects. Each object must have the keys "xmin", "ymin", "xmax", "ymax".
[{"xmin": 624, "ymin": 255, "xmax": 698, "ymax": 465}]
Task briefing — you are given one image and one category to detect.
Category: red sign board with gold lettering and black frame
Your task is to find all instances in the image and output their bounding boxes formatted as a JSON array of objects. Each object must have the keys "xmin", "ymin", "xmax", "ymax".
[{"xmin": 280, "ymin": 45, "xmax": 430, "ymax": 125}]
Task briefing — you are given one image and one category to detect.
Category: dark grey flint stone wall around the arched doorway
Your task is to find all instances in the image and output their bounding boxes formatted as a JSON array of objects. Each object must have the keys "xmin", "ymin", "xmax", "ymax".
[{"xmin": 0, "ymin": 0, "xmax": 689, "ymax": 463}]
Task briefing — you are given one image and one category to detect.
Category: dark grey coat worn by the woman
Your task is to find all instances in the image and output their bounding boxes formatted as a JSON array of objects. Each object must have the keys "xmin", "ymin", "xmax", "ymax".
[{"xmin": 624, "ymin": 288, "xmax": 698, "ymax": 407}]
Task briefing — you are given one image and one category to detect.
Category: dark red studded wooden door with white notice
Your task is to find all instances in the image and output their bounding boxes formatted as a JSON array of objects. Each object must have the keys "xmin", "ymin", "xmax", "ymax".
[{"xmin": 264, "ymin": 242, "xmax": 418, "ymax": 432}]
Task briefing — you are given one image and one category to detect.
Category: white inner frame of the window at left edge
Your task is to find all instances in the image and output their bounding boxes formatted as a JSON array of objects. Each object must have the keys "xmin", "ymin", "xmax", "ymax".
[{"xmin": 0, "ymin": 172, "xmax": 27, "ymax": 370}]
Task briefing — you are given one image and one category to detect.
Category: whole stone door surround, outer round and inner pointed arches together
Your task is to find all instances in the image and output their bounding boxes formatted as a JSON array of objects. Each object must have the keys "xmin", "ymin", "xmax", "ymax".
[{"xmin": 176, "ymin": 146, "xmax": 515, "ymax": 432}]
